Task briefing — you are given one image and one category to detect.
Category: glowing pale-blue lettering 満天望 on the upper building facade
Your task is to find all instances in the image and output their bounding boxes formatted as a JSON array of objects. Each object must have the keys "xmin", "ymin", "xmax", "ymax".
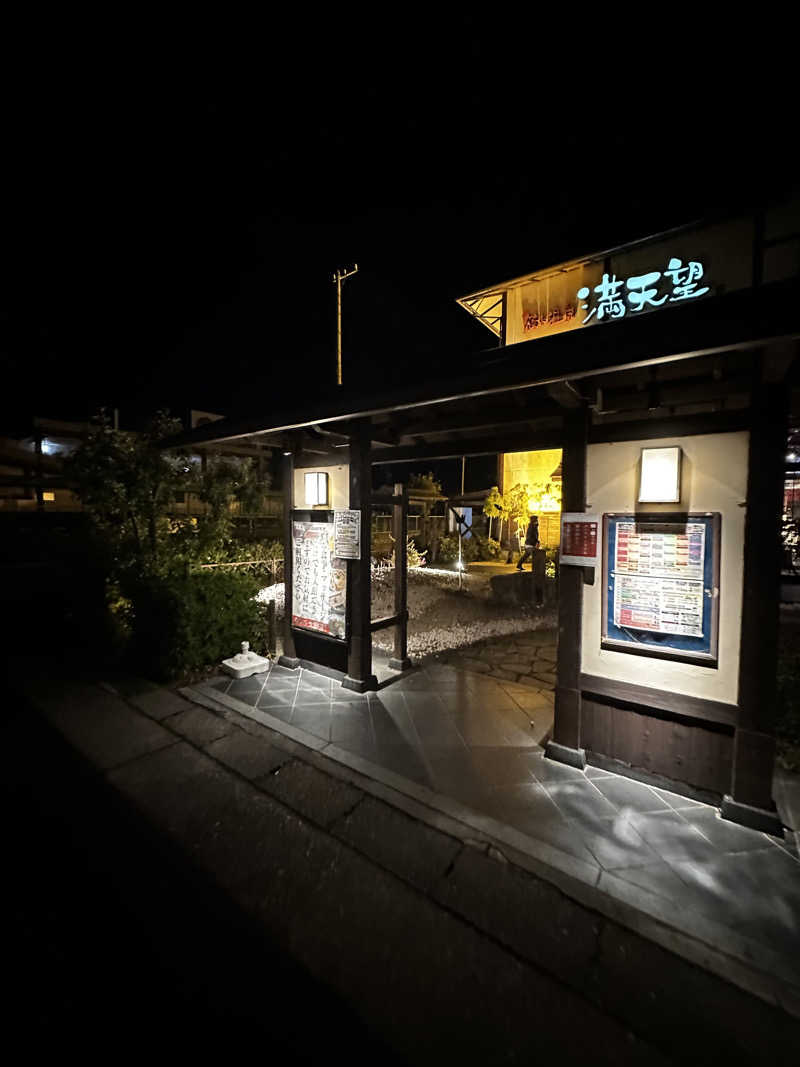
[{"xmin": 577, "ymin": 256, "xmax": 708, "ymax": 325}]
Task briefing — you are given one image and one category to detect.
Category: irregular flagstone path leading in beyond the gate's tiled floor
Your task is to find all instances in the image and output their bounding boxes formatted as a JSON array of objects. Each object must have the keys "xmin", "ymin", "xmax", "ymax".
[{"xmin": 435, "ymin": 630, "xmax": 558, "ymax": 690}]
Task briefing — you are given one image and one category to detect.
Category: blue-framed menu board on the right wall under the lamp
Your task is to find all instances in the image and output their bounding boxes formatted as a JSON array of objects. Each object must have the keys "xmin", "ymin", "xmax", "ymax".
[{"xmin": 602, "ymin": 514, "xmax": 720, "ymax": 660}]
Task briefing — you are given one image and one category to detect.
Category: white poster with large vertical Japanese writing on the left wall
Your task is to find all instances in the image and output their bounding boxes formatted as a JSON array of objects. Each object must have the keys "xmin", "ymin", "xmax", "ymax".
[{"xmin": 291, "ymin": 521, "xmax": 347, "ymax": 640}]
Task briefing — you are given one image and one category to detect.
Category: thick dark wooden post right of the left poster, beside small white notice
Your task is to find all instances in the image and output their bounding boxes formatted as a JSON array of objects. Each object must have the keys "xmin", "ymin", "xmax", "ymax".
[{"xmin": 341, "ymin": 419, "xmax": 378, "ymax": 692}]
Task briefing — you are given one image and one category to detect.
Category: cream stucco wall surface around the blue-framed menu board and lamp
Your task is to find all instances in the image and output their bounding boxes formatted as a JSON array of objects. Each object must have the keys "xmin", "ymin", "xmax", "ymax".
[{"xmin": 581, "ymin": 432, "xmax": 749, "ymax": 703}]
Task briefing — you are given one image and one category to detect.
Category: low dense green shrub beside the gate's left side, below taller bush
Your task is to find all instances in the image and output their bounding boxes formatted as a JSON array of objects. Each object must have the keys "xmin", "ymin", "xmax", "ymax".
[{"xmin": 123, "ymin": 568, "xmax": 267, "ymax": 680}]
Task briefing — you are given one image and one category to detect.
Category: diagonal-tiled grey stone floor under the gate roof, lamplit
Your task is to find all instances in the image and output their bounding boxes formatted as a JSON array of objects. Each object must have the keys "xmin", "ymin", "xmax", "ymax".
[{"xmin": 204, "ymin": 664, "xmax": 800, "ymax": 977}]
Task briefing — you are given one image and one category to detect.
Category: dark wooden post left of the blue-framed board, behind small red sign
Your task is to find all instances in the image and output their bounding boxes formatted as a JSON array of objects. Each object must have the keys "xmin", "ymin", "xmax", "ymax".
[{"xmin": 546, "ymin": 408, "xmax": 590, "ymax": 768}]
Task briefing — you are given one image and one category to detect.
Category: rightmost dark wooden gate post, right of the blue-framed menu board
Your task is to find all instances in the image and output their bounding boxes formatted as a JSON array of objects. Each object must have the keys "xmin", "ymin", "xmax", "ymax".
[{"xmin": 721, "ymin": 356, "xmax": 790, "ymax": 833}]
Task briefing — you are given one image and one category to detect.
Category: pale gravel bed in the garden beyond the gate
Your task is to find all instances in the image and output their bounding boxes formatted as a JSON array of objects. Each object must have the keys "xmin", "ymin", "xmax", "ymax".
[{"xmin": 257, "ymin": 569, "xmax": 556, "ymax": 659}]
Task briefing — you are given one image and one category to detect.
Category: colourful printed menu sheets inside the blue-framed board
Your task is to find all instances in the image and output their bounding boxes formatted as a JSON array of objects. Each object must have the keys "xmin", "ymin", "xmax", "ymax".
[{"xmin": 613, "ymin": 523, "xmax": 706, "ymax": 637}]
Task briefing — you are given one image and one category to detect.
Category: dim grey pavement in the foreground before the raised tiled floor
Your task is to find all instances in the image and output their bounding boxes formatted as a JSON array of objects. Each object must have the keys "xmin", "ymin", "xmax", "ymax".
[{"xmin": 10, "ymin": 665, "xmax": 800, "ymax": 1064}]
